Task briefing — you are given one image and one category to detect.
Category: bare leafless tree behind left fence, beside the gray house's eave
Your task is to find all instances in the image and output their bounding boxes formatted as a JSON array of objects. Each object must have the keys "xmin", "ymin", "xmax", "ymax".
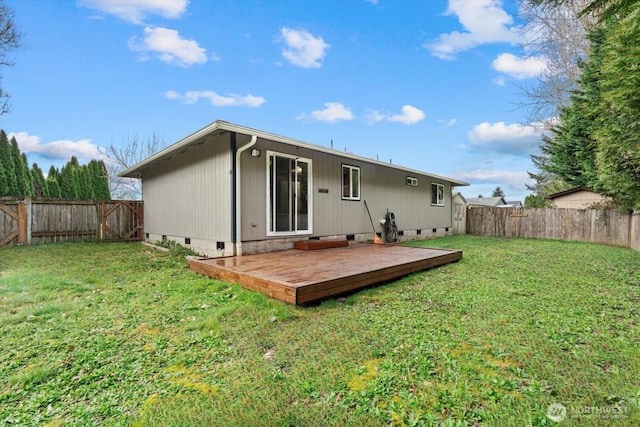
[{"xmin": 101, "ymin": 133, "xmax": 166, "ymax": 200}]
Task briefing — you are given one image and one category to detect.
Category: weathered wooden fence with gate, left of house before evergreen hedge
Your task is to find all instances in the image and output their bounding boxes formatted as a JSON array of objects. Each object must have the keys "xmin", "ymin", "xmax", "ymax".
[{"xmin": 0, "ymin": 198, "xmax": 144, "ymax": 247}]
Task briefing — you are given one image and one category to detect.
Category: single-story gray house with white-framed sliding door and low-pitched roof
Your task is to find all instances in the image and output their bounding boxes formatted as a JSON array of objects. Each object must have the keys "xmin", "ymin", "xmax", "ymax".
[{"xmin": 120, "ymin": 121, "xmax": 468, "ymax": 257}]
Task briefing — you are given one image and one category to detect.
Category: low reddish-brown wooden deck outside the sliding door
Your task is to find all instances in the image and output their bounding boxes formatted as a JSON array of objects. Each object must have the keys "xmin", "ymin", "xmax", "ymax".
[{"xmin": 189, "ymin": 243, "xmax": 462, "ymax": 304}]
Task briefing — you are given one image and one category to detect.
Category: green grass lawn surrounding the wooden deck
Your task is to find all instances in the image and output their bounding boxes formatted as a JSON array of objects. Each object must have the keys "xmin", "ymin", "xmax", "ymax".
[{"xmin": 0, "ymin": 236, "xmax": 640, "ymax": 426}]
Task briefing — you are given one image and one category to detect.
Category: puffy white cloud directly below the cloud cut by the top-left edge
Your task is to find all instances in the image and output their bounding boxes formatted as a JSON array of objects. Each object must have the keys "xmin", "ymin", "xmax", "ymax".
[{"xmin": 129, "ymin": 27, "xmax": 209, "ymax": 67}]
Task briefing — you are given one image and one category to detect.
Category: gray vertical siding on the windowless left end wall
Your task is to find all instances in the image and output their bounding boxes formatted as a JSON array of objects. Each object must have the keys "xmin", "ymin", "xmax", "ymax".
[{"xmin": 143, "ymin": 134, "xmax": 232, "ymax": 243}]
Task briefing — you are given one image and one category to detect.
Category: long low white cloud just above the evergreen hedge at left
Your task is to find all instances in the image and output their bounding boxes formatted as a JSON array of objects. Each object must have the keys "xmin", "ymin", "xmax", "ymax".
[{"xmin": 8, "ymin": 132, "xmax": 104, "ymax": 161}]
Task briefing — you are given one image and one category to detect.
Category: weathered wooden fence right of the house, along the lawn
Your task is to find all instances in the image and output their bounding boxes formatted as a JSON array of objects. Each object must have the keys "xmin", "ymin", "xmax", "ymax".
[{"xmin": 466, "ymin": 207, "xmax": 640, "ymax": 251}]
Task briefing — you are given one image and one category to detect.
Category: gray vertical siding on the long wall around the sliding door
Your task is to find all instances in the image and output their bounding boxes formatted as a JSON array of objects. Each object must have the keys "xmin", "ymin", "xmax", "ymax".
[{"xmin": 242, "ymin": 139, "xmax": 452, "ymax": 241}]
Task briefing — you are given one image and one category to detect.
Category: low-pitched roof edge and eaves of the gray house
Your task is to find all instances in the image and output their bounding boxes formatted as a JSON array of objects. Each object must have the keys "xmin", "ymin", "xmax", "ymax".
[{"xmin": 118, "ymin": 120, "xmax": 469, "ymax": 186}]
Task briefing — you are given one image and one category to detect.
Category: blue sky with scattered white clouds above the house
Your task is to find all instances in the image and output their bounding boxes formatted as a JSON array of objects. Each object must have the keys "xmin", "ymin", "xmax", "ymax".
[{"xmin": 0, "ymin": 0, "xmax": 544, "ymax": 200}]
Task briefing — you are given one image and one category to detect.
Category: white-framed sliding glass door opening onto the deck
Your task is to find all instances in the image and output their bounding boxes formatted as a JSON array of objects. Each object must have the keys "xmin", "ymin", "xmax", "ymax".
[{"xmin": 267, "ymin": 152, "xmax": 312, "ymax": 235}]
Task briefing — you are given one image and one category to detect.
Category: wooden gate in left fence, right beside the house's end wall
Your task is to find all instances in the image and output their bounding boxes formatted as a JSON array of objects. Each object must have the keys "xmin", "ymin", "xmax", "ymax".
[{"xmin": 100, "ymin": 200, "xmax": 144, "ymax": 242}]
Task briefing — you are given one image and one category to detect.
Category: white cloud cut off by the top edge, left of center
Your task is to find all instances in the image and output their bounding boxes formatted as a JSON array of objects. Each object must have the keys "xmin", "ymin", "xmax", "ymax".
[{"xmin": 78, "ymin": 0, "xmax": 189, "ymax": 24}]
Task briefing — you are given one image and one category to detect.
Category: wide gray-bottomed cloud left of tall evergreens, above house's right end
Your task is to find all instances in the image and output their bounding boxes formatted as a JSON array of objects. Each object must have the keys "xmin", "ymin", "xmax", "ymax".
[{"xmin": 467, "ymin": 122, "xmax": 545, "ymax": 156}]
